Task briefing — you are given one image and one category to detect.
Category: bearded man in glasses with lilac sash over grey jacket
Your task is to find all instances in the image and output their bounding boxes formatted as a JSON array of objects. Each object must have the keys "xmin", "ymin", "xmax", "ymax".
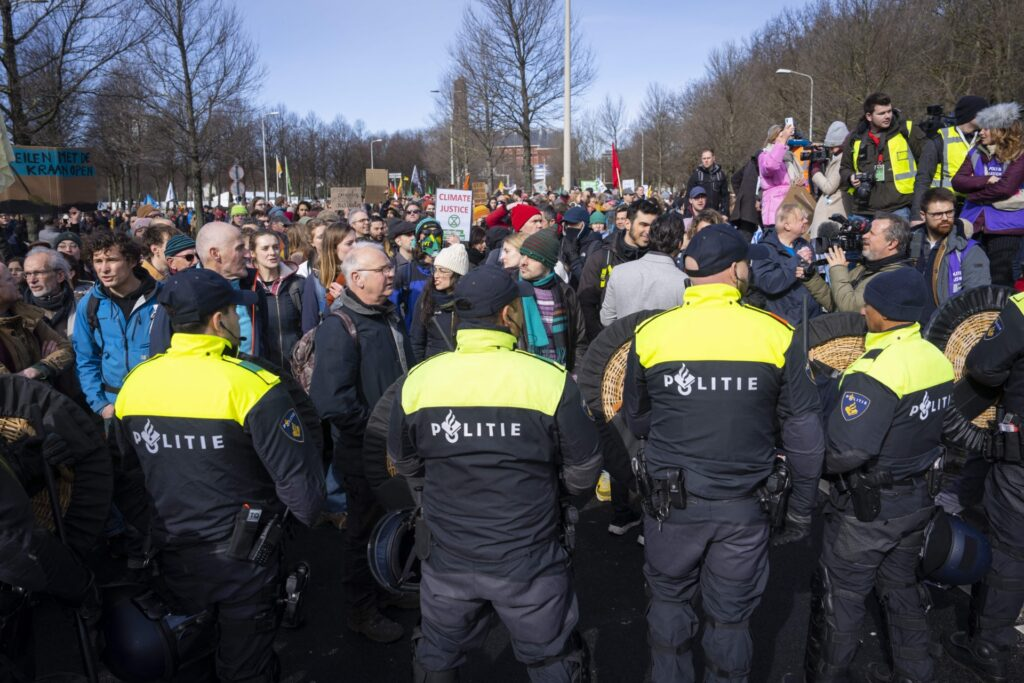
[{"xmin": 910, "ymin": 187, "xmax": 992, "ymax": 319}]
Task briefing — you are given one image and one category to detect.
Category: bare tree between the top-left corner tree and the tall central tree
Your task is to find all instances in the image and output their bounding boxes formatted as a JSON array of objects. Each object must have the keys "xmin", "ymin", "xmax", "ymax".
[{"xmin": 140, "ymin": 0, "xmax": 262, "ymax": 228}]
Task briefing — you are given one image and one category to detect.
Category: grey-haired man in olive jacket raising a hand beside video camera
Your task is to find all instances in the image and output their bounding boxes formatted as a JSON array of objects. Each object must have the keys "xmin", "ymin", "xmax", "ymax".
[{"xmin": 806, "ymin": 213, "xmax": 910, "ymax": 313}]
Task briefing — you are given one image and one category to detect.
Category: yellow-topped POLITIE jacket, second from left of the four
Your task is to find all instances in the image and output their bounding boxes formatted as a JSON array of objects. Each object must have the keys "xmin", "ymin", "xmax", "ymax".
[{"xmin": 388, "ymin": 328, "xmax": 601, "ymax": 570}]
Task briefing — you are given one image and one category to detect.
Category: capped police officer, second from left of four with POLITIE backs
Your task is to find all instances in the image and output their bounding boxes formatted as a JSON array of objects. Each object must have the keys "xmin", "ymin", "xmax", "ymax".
[{"xmin": 388, "ymin": 265, "xmax": 601, "ymax": 683}]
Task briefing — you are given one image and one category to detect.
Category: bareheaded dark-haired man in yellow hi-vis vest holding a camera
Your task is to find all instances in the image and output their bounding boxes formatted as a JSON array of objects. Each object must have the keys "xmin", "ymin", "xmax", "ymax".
[{"xmin": 840, "ymin": 92, "xmax": 927, "ymax": 220}]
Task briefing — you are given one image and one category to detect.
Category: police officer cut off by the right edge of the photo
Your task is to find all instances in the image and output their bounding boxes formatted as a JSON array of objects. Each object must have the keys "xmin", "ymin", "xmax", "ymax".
[{"xmin": 943, "ymin": 292, "xmax": 1024, "ymax": 682}]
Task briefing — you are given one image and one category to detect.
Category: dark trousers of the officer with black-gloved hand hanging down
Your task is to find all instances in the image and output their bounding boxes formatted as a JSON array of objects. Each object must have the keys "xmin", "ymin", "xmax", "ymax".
[{"xmin": 643, "ymin": 496, "xmax": 768, "ymax": 683}]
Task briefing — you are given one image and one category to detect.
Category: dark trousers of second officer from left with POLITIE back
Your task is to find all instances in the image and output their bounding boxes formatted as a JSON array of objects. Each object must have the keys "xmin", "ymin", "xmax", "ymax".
[{"xmin": 414, "ymin": 541, "xmax": 584, "ymax": 683}]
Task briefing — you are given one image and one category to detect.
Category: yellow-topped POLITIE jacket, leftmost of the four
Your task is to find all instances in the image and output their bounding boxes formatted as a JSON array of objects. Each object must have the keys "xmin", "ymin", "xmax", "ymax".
[{"xmin": 115, "ymin": 333, "xmax": 325, "ymax": 546}]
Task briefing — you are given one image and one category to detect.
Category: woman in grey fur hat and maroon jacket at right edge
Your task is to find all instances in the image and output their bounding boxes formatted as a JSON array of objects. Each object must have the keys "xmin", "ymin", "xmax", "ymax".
[{"xmin": 952, "ymin": 102, "xmax": 1024, "ymax": 287}]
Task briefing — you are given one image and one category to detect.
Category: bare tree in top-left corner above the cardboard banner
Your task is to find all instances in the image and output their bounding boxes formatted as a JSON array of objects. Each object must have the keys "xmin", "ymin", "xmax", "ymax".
[{"xmin": 0, "ymin": 0, "xmax": 145, "ymax": 144}]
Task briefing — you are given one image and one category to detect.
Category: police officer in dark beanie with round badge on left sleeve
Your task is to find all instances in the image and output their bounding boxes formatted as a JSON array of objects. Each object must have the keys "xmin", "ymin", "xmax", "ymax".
[{"xmin": 805, "ymin": 268, "xmax": 953, "ymax": 683}]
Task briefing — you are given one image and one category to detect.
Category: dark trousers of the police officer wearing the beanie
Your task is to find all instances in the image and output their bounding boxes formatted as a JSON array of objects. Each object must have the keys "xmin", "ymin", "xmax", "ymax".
[{"xmin": 805, "ymin": 477, "xmax": 934, "ymax": 682}]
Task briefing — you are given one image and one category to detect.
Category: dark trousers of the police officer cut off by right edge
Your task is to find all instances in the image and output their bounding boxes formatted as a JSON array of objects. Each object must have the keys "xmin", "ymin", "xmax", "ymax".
[{"xmin": 969, "ymin": 463, "xmax": 1024, "ymax": 656}]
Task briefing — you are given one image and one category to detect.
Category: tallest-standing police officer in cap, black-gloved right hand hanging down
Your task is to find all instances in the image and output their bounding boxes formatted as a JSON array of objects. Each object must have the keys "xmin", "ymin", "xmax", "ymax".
[{"xmin": 623, "ymin": 224, "xmax": 824, "ymax": 683}]
